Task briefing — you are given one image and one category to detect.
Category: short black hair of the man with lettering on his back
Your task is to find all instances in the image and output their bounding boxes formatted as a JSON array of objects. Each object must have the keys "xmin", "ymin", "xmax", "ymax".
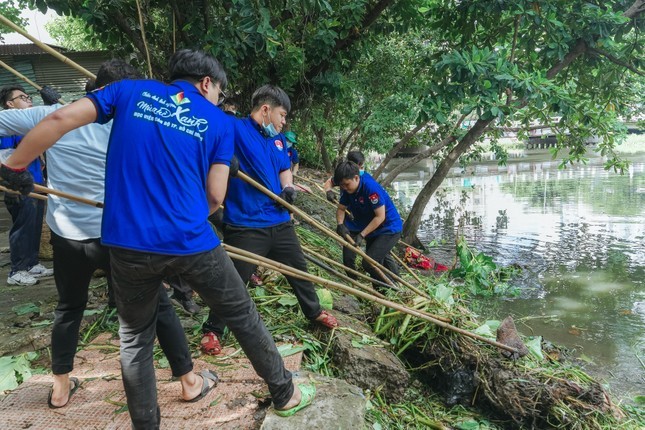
[{"xmin": 168, "ymin": 49, "xmax": 228, "ymax": 91}]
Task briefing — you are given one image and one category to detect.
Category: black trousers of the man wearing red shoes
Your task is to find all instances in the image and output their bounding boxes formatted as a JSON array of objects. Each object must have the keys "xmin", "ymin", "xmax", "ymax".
[{"xmin": 202, "ymin": 222, "xmax": 322, "ymax": 336}]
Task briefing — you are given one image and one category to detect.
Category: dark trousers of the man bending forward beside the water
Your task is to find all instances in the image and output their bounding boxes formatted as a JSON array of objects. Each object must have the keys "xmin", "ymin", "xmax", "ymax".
[{"xmin": 343, "ymin": 231, "xmax": 401, "ymax": 290}]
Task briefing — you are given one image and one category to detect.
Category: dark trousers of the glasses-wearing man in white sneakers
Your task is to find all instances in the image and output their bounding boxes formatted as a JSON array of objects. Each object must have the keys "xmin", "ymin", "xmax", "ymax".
[{"xmin": 4, "ymin": 193, "xmax": 45, "ymax": 276}]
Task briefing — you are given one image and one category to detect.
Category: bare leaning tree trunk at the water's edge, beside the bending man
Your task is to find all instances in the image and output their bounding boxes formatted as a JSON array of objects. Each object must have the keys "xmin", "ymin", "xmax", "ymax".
[{"xmin": 402, "ymin": 119, "xmax": 493, "ymax": 241}]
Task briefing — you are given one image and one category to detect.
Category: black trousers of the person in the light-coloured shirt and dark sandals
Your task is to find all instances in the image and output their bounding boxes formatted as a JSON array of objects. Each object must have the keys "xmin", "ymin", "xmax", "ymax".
[{"xmin": 51, "ymin": 232, "xmax": 193, "ymax": 377}]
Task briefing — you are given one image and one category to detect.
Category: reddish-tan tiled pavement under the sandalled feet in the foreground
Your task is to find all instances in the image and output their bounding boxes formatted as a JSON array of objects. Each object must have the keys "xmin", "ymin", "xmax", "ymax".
[{"xmin": 0, "ymin": 333, "xmax": 302, "ymax": 430}]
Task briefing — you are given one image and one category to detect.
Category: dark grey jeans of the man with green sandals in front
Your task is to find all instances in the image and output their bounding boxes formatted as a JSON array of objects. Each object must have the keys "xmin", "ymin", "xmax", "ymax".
[{"xmin": 110, "ymin": 246, "xmax": 294, "ymax": 429}]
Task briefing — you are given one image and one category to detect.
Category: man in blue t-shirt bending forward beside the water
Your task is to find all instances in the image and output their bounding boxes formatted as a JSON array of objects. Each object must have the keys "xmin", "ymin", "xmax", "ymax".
[{"xmin": 334, "ymin": 161, "xmax": 403, "ymax": 288}]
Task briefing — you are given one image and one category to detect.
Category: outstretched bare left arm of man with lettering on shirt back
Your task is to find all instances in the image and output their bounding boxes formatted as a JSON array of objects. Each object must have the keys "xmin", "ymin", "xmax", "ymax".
[{"xmin": 5, "ymin": 98, "xmax": 97, "ymax": 169}]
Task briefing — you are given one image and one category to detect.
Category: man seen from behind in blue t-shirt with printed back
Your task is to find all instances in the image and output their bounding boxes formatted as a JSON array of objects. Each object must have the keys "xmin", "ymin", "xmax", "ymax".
[{"xmin": 0, "ymin": 49, "xmax": 313, "ymax": 428}]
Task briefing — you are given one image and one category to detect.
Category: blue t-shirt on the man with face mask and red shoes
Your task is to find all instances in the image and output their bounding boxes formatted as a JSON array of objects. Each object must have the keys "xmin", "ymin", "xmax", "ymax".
[{"xmin": 224, "ymin": 117, "xmax": 291, "ymax": 228}]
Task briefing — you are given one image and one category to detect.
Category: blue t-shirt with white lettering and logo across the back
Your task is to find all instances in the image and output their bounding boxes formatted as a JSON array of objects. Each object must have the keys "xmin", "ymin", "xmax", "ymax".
[{"xmin": 87, "ymin": 80, "xmax": 233, "ymax": 255}]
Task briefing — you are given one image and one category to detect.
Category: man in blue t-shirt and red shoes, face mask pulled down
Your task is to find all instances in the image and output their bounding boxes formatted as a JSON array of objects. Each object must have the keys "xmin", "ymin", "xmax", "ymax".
[{"xmin": 201, "ymin": 85, "xmax": 338, "ymax": 355}]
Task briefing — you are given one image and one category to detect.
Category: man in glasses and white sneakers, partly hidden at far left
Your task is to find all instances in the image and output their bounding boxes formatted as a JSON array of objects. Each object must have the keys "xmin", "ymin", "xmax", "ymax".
[{"xmin": 0, "ymin": 85, "xmax": 54, "ymax": 285}]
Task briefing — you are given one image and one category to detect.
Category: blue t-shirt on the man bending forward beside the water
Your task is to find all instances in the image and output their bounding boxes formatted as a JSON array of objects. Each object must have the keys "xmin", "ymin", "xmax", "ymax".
[{"xmin": 339, "ymin": 173, "xmax": 403, "ymax": 237}]
